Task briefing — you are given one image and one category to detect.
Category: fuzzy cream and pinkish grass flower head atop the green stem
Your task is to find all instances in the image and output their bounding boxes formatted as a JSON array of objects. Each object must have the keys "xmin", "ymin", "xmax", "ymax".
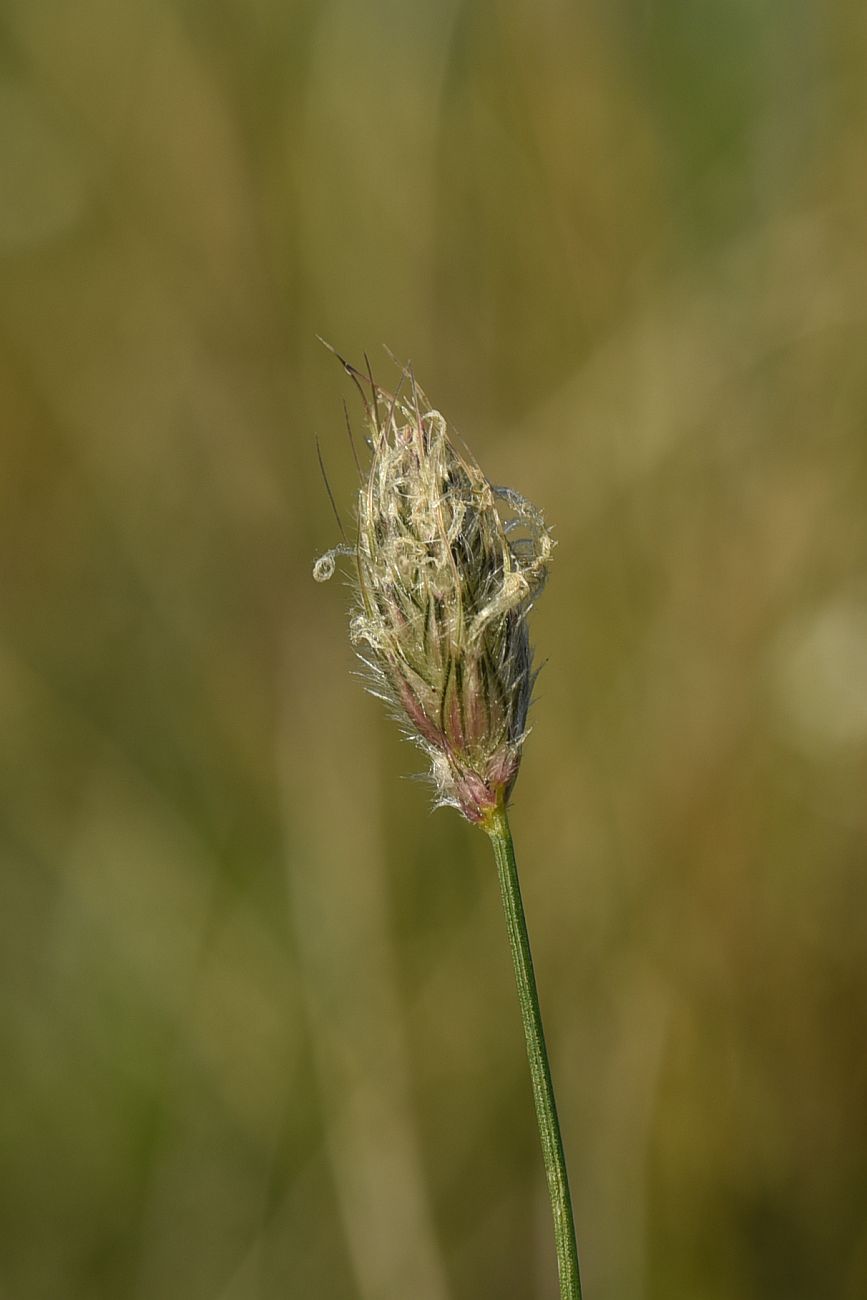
[{"xmin": 313, "ymin": 361, "xmax": 554, "ymax": 822}]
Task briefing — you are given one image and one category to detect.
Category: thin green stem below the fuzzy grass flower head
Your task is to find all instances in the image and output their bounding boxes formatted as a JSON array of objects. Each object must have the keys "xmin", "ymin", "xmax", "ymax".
[{"xmin": 485, "ymin": 807, "xmax": 581, "ymax": 1300}]
